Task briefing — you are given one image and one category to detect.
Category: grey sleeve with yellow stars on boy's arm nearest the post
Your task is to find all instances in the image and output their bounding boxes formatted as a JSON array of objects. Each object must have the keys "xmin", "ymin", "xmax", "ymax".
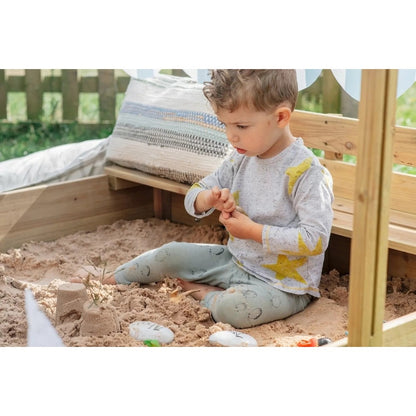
[{"xmin": 262, "ymin": 166, "xmax": 333, "ymax": 256}]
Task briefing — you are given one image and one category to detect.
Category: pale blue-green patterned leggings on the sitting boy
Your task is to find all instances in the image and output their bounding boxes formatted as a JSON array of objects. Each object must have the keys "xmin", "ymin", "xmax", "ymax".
[{"xmin": 114, "ymin": 242, "xmax": 311, "ymax": 328}]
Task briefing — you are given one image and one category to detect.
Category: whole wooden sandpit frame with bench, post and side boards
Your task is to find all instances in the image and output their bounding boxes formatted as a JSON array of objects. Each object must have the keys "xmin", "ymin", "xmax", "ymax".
[{"xmin": 0, "ymin": 69, "xmax": 416, "ymax": 346}]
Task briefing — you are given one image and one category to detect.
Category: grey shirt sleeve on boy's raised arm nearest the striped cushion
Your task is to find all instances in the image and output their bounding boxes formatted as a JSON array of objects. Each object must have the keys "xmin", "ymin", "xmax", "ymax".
[{"xmin": 185, "ymin": 152, "xmax": 239, "ymax": 218}]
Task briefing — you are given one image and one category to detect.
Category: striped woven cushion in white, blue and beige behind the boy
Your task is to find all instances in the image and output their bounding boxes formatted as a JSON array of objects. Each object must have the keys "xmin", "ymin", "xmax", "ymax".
[{"xmin": 106, "ymin": 75, "xmax": 230, "ymax": 184}]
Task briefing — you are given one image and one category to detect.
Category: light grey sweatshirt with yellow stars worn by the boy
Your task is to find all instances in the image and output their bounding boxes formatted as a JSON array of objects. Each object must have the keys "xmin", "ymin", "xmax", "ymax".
[{"xmin": 185, "ymin": 138, "xmax": 333, "ymax": 297}]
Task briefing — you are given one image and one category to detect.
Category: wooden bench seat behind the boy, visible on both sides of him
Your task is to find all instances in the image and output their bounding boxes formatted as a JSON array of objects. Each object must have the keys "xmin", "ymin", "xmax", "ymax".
[{"xmin": 105, "ymin": 165, "xmax": 416, "ymax": 255}]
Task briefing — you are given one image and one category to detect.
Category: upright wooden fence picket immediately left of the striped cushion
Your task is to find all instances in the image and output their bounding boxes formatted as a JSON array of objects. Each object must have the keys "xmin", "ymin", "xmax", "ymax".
[{"xmin": 98, "ymin": 69, "xmax": 116, "ymax": 122}]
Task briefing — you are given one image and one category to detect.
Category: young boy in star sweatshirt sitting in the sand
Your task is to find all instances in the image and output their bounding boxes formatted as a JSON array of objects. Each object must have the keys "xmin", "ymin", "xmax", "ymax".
[{"xmin": 96, "ymin": 69, "xmax": 333, "ymax": 328}]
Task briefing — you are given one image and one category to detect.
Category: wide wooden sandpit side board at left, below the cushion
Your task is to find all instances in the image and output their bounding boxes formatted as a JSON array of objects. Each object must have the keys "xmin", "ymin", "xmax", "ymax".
[{"xmin": 0, "ymin": 175, "xmax": 153, "ymax": 251}]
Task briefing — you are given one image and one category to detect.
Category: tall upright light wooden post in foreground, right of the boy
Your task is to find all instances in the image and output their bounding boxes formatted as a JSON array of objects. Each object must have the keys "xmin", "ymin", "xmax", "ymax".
[{"xmin": 348, "ymin": 70, "xmax": 397, "ymax": 346}]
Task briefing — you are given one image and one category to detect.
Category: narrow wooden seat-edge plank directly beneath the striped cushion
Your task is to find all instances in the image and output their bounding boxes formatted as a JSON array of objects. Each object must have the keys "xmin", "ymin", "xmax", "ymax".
[{"xmin": 104, "ymin": 165, "xmax": 190, "ymax": 195}]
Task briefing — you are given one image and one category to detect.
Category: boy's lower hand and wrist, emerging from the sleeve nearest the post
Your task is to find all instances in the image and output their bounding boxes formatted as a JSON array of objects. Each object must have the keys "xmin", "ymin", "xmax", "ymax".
[{"xmin": 219, "ymin": 209, "xmax": 263, "ymax": 244}]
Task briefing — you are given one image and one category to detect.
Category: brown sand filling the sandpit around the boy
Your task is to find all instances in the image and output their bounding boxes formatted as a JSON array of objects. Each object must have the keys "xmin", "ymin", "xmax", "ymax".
[{"xmin": 0, "ymin": 218, "xmax": 416, "ymax": 347}]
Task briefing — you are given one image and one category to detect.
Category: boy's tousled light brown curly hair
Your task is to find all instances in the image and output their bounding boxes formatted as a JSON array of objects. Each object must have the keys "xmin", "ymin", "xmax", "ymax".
[{"xmin": 203, "ymin": 69, "xmax": 298, "ymax": 112}]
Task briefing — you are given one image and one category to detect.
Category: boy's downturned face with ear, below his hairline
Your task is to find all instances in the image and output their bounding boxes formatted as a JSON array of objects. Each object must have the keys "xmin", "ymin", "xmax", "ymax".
[{"xmin": 217, "ymin": 107, "xmax": 294, "ymax": 159}]
